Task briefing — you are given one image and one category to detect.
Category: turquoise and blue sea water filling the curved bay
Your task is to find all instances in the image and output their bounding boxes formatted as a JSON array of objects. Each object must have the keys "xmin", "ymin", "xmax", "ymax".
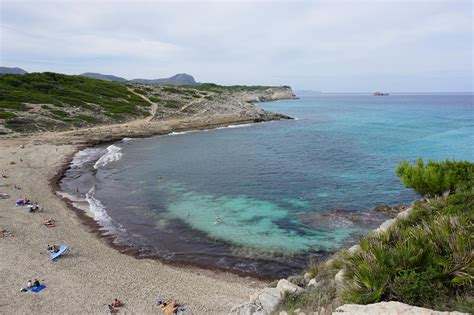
[{"xmin": 62, "ymin": 94, "xmax": 474, "ymax": 277}]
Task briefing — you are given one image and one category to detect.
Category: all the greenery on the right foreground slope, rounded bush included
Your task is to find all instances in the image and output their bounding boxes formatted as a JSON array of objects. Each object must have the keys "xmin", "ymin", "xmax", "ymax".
[{"xmin": 282, "ymin": 160, "xmax": 474, "ymax": 312}]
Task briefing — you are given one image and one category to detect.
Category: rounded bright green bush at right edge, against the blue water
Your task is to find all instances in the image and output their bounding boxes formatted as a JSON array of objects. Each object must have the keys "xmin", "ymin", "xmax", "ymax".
[{"xmin": 397, "ymin": 159, "xmax": 474, "ymax": 197}]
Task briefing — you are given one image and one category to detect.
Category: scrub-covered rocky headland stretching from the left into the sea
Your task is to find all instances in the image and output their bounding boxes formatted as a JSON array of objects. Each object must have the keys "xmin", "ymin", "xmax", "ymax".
[{"xmin": 0, "ymin": 73, "xmax": 295, "ymax": 143}]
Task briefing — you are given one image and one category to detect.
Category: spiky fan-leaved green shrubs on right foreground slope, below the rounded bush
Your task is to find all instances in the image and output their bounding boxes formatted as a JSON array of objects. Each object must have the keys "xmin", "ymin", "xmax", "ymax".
[{"xmin": 341, "ymin": 190, "xmax": 474, "ymax": 311}]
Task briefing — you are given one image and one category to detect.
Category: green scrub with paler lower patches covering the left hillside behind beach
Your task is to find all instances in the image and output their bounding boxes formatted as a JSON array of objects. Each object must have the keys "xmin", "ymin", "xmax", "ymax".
[{"xmin": 0, "ymin": 72, "xmax": 150, "ymax": 132}]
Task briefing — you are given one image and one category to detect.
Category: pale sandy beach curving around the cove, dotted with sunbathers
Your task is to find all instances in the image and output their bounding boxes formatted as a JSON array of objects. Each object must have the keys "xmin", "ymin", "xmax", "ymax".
[{"xmin": 0, "ymin": 131, "xmax": 265, "ymax": 314}]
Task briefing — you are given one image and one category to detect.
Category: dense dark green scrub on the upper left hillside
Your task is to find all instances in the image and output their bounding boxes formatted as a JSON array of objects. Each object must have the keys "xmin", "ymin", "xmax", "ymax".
[{"xmin": 0, "ymin": 72, "xmax": 149, "ymax": 120}]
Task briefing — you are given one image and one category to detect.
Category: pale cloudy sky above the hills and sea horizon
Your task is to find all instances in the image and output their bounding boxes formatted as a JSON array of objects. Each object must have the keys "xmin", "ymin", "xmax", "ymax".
[{"xmin": 0, "ymin": 0, "xmax": 474, "ymax": 93}]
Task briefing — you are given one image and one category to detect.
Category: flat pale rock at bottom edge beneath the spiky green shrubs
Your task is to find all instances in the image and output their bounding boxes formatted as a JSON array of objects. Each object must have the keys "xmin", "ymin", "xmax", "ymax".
[{"xmin": 333, "ymin": 302, "xmax": 467, "ymax": 315}]
